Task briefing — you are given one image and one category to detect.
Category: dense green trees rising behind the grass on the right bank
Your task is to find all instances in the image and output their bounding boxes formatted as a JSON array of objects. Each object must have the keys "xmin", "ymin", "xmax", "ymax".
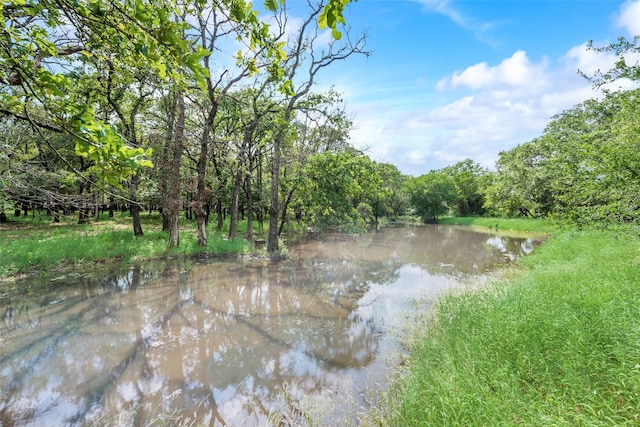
[{"xmin": 487, "ymin": 89, "xmax": 640, "ymax": 223}]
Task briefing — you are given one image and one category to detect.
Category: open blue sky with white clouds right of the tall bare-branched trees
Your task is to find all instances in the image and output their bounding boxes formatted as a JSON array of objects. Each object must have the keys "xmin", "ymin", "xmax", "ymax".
[{"xmin": 298, "ymin": 0, "xmax": 640, "ymax": 176}]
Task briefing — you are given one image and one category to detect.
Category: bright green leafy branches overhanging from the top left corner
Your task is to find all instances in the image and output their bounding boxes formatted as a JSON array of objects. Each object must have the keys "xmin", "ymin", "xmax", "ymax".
[{"xmin": 0, "ymin": 0, "xmax": 200, "ymax": 185}]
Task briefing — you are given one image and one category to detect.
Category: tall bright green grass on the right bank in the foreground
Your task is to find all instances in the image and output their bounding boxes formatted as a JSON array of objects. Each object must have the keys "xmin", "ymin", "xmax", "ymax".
[{"xmin": 373, "ymin": 224, "xmax": 640, "ymax": 426}]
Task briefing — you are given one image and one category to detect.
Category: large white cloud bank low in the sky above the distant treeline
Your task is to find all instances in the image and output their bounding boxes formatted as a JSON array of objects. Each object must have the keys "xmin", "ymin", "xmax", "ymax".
[{"xmin": 352, "ymin": 45, "xmax": 612, "ymax": 176}]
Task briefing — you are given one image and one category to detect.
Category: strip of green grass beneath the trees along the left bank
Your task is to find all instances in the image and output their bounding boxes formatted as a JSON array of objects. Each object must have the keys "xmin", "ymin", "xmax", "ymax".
[{"xmin": 0, "ymin": 214, "xmax": 252, "ymax": 279}]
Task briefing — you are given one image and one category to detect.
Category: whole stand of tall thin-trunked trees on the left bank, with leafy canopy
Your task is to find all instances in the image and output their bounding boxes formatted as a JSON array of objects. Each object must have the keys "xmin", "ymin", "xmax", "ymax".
[{"xmin": 0, "ymin": 0, "xmax": 369, "ymax": 252}]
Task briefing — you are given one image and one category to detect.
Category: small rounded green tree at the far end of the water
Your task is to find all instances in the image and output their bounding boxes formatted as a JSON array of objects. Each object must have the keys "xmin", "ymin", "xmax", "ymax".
[{"xmin": 405, "ymin": 171, "xmax": 458, "ymax": 222}]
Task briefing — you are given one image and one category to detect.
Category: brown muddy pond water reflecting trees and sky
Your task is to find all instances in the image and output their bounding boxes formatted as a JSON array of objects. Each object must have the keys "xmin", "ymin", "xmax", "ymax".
[{"xmin": 0, "ymin": 226, "xmax": 535, "ymax": 426}]
